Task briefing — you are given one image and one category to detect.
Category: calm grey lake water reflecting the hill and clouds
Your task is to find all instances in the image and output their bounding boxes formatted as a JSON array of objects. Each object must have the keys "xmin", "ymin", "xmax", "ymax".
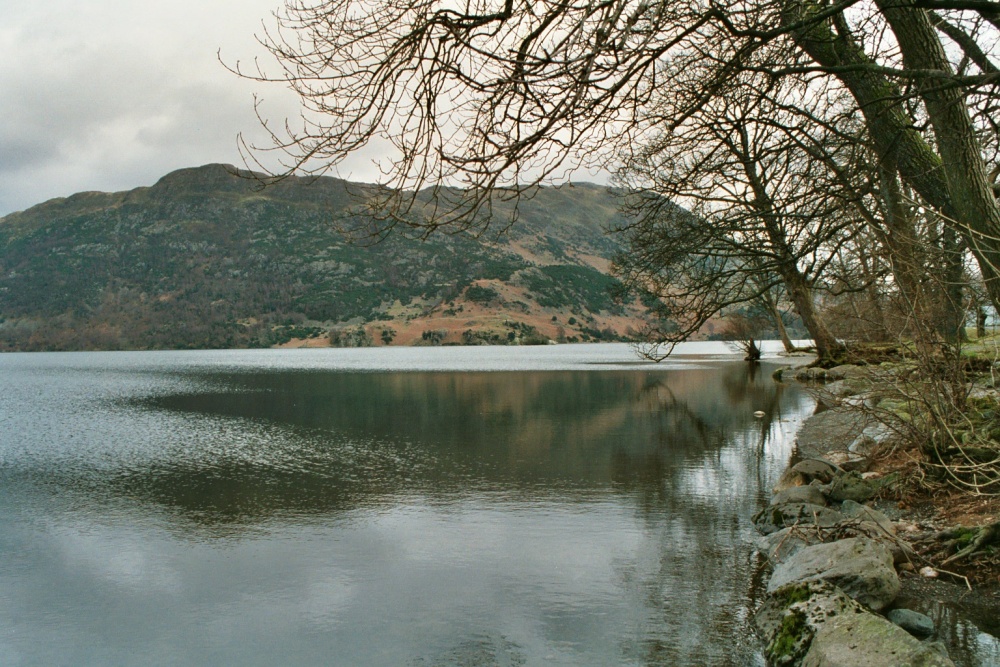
[{"xmin": 0, "ymin": 345, "xmax": 996, "ymax": 666}]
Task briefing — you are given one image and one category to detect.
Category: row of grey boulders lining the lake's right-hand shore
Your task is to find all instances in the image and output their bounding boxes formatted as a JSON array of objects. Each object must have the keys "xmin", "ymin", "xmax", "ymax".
[{"xmin": 754, "ymin": 367, "xmax": 954, "ymax": 667}]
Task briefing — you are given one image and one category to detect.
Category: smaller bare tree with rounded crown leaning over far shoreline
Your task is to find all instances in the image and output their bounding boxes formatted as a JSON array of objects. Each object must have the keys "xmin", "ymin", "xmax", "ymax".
[{"xmin": 616, "ymin": 73, "xmax": 861, "ymax": 361}]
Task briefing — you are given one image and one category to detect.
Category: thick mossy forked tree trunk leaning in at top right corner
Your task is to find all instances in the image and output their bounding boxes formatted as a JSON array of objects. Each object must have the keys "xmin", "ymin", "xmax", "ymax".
[{"xmin": 784, "ymin": 0, "xmax": 1000, "ymax": 308}]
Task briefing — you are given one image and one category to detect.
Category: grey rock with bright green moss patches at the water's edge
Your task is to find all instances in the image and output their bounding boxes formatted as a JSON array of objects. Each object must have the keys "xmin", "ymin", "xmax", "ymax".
[{"xmin": 753, "ymin": 581, "xmax": 862, "ymax": 665}]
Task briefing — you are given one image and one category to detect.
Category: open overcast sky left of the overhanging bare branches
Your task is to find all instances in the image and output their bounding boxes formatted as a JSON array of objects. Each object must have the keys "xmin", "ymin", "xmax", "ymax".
[{"xmin": 0, "ymin": 0, "xmax": 386, "ymax": 216}]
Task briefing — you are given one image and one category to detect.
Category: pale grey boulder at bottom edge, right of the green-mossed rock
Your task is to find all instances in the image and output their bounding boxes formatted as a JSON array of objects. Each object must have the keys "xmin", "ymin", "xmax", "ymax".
[{"xmin": 802, "ymin": 613, "xmax": 955, "ymax": 667}]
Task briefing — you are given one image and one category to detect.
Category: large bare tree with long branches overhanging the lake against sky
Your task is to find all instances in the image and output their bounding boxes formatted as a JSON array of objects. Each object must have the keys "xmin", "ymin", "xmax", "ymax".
[{"xmin": 235, "ymin": 0, "xmax": 1000, "ymax": 320}]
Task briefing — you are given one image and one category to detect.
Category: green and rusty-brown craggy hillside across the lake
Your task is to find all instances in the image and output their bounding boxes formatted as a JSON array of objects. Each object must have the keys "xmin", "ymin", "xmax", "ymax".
[{"xmin": 0, "ymin": 165, "xmax": 641, "ymax": 350}]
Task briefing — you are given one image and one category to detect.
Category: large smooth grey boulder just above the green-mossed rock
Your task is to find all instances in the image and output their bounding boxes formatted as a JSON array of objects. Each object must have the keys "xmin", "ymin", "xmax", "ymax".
[{"xmin": 767, "ymin": 537, "xmax": 900, "ymax": 611}]
